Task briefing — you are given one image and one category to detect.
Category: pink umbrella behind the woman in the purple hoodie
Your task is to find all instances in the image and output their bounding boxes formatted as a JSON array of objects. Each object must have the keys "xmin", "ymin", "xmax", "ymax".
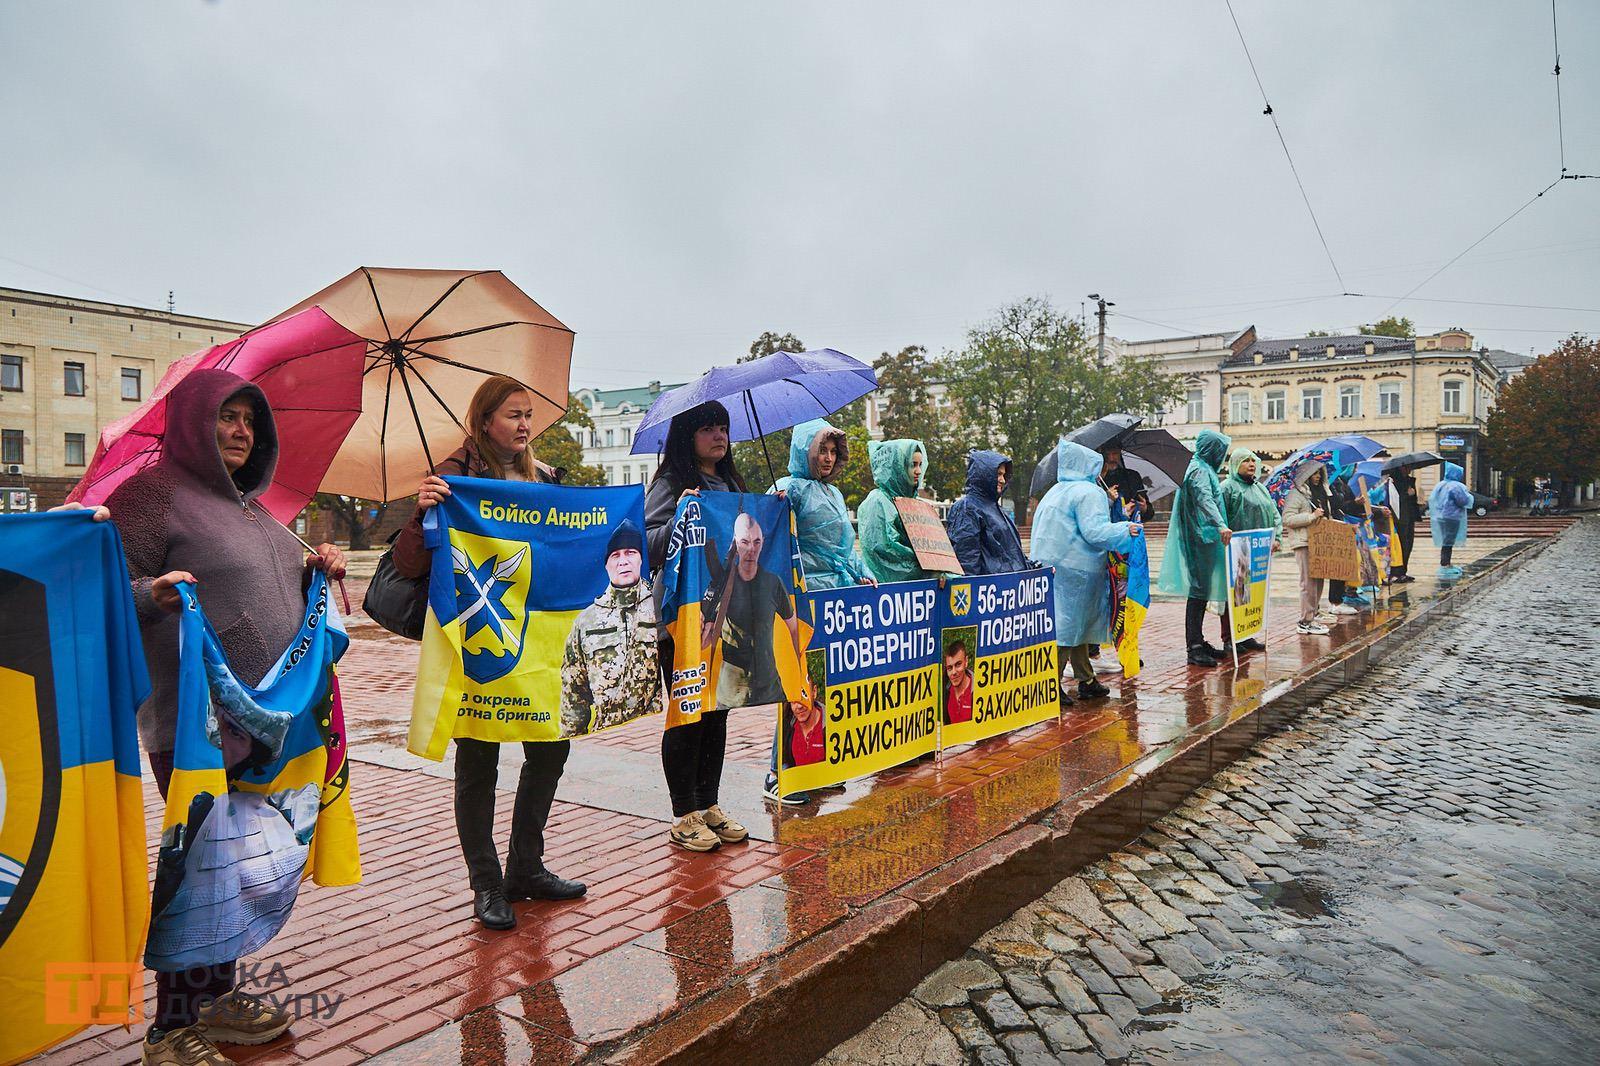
[{"xmin": 67, "ymin": 307, "xmax": 366, "ymax": 525}]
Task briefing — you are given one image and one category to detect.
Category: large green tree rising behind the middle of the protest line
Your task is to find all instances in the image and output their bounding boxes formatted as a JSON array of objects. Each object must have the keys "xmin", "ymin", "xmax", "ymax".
[{"xmin": 949, "ymin": 296, "xmax": 1182, "ymax": 515}]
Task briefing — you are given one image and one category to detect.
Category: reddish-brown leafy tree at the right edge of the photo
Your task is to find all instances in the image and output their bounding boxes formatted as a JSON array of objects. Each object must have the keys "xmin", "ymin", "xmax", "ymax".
[{"xmin": 1486, "ymin": 333, "xmax": 1600, "ymax": 502}]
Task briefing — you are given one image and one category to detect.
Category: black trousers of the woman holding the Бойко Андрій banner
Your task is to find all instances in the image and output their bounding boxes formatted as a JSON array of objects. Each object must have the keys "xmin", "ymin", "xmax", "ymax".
[{"xmin": 456, "ymin": 736, "xmax": 573, "ymax": 892}]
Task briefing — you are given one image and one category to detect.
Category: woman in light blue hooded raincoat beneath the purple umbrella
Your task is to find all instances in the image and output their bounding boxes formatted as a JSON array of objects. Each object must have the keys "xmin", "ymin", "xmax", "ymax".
[{"xmin": 773, "ymin": 418, "xmax": 867, "ymax": 589}]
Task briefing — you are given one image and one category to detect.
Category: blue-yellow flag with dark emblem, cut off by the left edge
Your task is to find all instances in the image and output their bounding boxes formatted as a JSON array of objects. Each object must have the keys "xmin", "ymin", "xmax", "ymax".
[{"xmin": 0, "ymin": 511, "xmax": 150, "ymax": 1061}]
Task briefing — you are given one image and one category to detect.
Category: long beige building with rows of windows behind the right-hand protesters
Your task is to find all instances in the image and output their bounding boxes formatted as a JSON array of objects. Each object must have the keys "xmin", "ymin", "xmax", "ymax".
[{"xmin": 1219, "ymin": 330, "xmax": 1504, "ymax": 491}]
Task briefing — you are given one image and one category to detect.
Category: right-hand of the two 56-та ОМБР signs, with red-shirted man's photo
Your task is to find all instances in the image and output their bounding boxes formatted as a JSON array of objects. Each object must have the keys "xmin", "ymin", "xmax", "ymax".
[{"xmin": 939, "ymin": 570, "xmax": 1061, "ymax": 747}]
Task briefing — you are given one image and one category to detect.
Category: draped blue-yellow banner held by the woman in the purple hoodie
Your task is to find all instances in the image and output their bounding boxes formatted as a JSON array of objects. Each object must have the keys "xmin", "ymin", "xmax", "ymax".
[{"xmin": 144, "ymin": 573, "xmax": 362, "ymax": 972}]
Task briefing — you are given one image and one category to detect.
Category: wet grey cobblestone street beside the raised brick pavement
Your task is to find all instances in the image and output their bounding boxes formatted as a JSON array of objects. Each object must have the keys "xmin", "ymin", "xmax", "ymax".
[{"xmin": 824, "ymin": 522, "xmax": 1600, "ymax": 1066}]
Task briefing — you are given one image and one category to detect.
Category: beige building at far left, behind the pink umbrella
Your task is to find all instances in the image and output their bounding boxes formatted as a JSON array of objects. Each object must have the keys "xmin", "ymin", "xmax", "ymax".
[{"xmin": 0, "ymin": 288, "xmax": 250, "ymax": 509}]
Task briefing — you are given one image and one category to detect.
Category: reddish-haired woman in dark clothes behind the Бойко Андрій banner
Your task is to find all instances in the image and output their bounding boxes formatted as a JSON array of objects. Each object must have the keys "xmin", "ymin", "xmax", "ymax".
[{"xmin": 394, "ymin": 375, "xmax": 587, "ymax": 930}]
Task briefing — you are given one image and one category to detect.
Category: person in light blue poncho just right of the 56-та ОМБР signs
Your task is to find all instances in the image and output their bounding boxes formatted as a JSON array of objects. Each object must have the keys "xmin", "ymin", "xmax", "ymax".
[{"xmin": 1032, "ymin": 437, "xmax": 1142, "ymax": 698}]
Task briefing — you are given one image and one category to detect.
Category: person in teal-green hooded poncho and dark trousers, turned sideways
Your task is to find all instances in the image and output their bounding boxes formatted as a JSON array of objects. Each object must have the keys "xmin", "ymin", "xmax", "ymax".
[{"xmin": 1157, "ymin": 429, "xmax": 1234, "ymax": 666}]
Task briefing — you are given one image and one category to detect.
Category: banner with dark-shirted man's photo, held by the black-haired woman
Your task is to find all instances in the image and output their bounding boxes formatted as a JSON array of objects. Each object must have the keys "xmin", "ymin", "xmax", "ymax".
[{"xmin": 661, "ymin": 493, "xmax": 803, "ymax": 728}]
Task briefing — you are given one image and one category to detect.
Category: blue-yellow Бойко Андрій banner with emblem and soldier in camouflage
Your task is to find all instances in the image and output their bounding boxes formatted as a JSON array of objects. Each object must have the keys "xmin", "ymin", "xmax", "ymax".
[{"xmin": 406, "ymin": 477, "xmax": 661, "ymax": 760}]
